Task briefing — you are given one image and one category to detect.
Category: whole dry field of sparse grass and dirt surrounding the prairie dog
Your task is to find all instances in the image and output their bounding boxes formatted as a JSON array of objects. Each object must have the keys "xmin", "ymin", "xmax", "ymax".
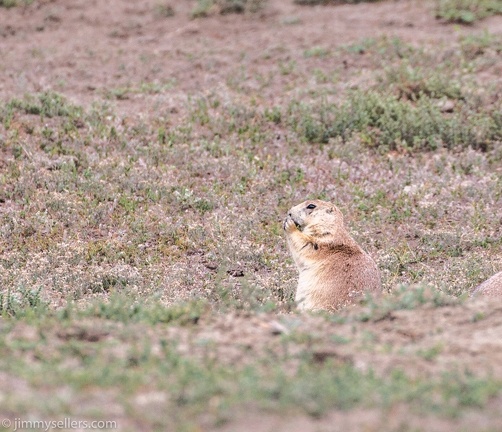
[{"xmin": 0, "ymin": 0, "xmax": 502, "ymax": 431}]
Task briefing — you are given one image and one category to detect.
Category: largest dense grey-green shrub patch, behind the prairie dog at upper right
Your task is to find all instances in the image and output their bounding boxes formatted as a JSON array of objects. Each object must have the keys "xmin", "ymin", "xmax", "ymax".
[{"xmin": 290, "ymin": 89, "xmax": 501, "ymax": 151}]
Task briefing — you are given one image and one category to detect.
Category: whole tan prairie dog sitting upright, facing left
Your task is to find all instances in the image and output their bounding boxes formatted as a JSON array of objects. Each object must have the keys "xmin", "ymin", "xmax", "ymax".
[{"xmin": 284, "ymin": 200, "xmax": 381, "ymax": 311}]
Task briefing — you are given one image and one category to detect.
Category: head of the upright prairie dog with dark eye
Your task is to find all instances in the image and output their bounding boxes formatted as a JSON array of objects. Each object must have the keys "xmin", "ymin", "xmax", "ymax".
[{"xmin": 288, "ymin": 200, "xmax": 343, "ymax": 236}]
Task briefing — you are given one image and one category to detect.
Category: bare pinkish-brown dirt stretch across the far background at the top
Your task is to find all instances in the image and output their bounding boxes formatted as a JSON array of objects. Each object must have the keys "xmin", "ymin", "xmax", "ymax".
[{"xmin": 0, "ymin": 0, "xmax": 502, "ymax": 112}]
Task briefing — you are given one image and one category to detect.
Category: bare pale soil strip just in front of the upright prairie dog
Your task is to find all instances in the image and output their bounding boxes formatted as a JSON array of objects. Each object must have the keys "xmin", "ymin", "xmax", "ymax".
[{"xmin": 175, "ymin": 299, "xmax": 502, "ymax": 378}]
